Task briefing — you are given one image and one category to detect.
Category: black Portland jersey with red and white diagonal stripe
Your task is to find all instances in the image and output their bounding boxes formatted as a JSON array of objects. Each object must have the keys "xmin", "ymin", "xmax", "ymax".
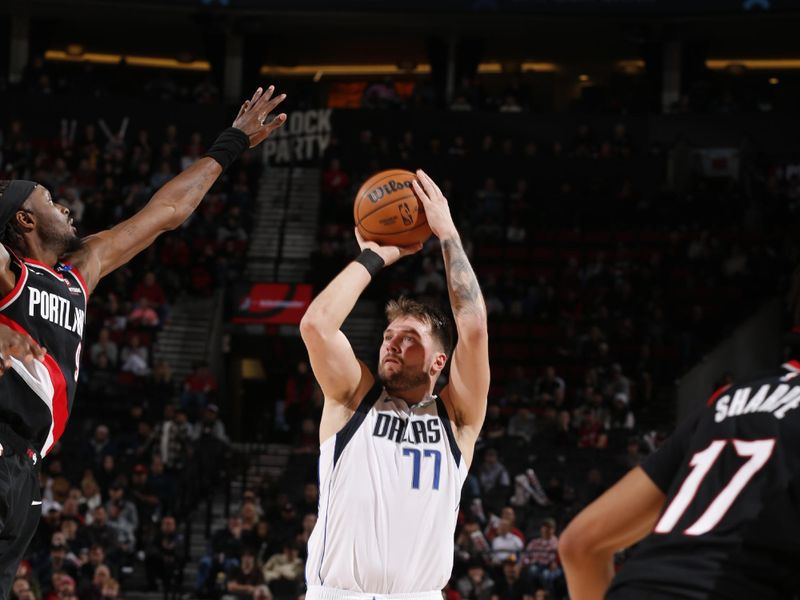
[{"xmin": 0, "ymin": 246, "xmax": 88, "ymax": 456}]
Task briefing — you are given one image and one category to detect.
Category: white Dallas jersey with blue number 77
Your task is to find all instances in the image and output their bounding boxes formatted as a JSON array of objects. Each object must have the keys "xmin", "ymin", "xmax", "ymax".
[{"xmin": 306, "ymin": 382, "xmax": 467, "ymax": 594}]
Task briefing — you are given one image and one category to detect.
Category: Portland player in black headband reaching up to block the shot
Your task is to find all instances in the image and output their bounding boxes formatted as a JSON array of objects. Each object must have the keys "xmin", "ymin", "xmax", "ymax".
[{"xmin": 0, "ymin": 86, "xmax": 286, "ymax": 598}]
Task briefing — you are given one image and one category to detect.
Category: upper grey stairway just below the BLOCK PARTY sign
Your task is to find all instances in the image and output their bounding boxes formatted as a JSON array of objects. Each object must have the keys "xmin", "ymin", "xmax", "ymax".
[{"xmin": 246, "ymin": 167, "xmax": 320, "ymax": 283}]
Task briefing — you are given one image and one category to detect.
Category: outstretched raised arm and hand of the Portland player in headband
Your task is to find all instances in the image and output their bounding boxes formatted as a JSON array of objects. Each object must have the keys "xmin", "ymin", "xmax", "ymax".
[{"xmin": 68, "ymin": 86, "xmax": 286, "ymax": 290}]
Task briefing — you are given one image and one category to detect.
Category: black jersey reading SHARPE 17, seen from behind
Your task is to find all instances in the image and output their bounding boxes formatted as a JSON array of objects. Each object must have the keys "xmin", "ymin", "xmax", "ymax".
[{"xmin": 608, "ymin": 361, "xmax": 800, "ymax": 600}]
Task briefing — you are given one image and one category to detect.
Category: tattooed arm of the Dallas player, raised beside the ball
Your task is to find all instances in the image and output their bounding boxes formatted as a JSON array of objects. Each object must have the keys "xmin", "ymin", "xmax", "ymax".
[{"xmin": 412, "ymin": 171, "xmax": 490, "ymax": 437}]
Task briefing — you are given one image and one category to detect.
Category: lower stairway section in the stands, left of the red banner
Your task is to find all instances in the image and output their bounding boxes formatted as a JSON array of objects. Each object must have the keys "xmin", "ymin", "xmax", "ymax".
[{"xmin": 153, "ymin": 294, "xmax": 222, "ymax": 382}]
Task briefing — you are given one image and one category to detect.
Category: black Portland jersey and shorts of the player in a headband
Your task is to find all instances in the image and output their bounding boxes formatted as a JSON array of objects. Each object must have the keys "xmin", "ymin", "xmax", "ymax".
[{"xmin": 0, "ymin": 249, "xmax": 88, "ymax": 597}]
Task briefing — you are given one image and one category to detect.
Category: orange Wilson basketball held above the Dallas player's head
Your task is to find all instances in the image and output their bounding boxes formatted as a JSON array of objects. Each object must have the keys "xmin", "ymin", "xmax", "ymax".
[{"xmin": 353, "ymin": 169, "xmax": 431, "ymax": 246}]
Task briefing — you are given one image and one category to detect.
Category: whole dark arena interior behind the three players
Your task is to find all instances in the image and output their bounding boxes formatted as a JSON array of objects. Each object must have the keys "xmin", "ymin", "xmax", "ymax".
[{"xmin": 0, "ymin": 0, "xmax": 800, "ymax": 600}]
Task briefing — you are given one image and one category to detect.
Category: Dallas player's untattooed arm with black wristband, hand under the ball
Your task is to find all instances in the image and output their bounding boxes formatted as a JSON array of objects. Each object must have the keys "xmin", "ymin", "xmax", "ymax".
[{"xmin": 300, "ymin": 231, "xmax": 422, "ymax": 406}]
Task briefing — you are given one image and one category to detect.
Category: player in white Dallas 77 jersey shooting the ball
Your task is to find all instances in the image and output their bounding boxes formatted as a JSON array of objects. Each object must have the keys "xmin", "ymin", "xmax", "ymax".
[{"xmin": 300, "ymin": 171, "xmax": 489, "ymax": 600}]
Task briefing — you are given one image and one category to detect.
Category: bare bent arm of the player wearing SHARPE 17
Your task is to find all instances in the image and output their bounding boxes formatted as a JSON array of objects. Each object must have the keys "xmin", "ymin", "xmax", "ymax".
[{"xmin": 558, "ymin": 467, "xmax": 665, "ymax": 600}]
